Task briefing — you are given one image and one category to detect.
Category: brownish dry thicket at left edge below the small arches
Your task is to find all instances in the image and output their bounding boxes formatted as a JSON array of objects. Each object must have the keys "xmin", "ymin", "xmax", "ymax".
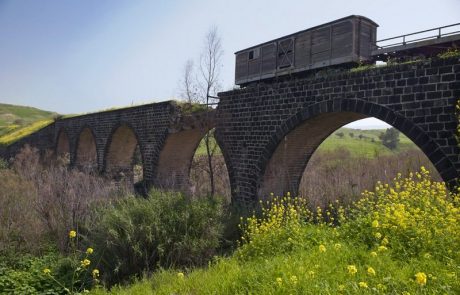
[{"xmin": 0, "ymin": 146, "xmax": 126, "ymax": 254}]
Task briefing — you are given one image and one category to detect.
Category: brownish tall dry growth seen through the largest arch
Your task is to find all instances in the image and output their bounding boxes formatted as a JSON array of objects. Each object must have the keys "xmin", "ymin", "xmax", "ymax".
[{"xmin": 299, "ymin": 148, "xmax": 441, "ymax": 207}]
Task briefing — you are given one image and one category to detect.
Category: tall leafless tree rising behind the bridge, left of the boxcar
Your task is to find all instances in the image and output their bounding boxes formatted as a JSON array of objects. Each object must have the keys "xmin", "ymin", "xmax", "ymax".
[{"xmin": 181, "ymin": 26, "xmax": 223, "ymax": 196}]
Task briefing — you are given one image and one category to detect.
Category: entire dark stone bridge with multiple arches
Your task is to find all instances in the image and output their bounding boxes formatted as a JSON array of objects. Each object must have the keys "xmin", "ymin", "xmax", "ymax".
[{"xmin": 4, "ymin": 57, "xmax": 460, "ymax": 203}]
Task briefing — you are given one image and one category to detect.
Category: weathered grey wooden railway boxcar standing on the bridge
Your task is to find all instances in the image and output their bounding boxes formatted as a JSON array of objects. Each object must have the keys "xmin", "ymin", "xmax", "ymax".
[{"xmin": 235, "ymin": 15, "xmax": 378, "ymax": 85}]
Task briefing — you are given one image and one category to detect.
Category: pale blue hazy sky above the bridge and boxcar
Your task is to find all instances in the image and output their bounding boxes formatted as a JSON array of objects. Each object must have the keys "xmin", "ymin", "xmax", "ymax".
[{"xmin": 0, "ymin": 0, "xmax": 460, "ymax": 128}]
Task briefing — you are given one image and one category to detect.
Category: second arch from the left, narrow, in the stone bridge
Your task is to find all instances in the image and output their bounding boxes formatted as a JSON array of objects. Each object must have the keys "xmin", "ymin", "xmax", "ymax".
[{"xmin": 75, "ymin": 126, "xmax": 98, "ymax": 171}]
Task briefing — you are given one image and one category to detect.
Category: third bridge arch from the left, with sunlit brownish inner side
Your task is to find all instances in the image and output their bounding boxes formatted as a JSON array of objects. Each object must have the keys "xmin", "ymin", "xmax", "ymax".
[{"xmin": 104, "ymin": 123, "xmax": 144, "ymax": 180}]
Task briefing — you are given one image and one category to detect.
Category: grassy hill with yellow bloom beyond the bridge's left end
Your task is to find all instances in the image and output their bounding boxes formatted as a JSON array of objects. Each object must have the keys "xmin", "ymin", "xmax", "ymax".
[{"xmin": 0, "ymin": 103, "xmax": 57, "ymax": 145}]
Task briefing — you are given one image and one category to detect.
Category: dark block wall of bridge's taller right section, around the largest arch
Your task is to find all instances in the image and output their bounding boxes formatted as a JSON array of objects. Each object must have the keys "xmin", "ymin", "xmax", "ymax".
[{"xmin": 216, "ymin": 58, "xmax": 460, "ymax": 202}]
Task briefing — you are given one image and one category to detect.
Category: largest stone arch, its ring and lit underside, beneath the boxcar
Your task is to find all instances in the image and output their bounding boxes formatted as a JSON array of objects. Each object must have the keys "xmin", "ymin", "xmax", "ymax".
[{"xmin": 257, "ymin": 99, "xmax": 457, "ymax": 198}]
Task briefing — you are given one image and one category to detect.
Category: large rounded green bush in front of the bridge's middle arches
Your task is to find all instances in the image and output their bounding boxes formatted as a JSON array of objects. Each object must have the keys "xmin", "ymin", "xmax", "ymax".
[{"xmin": 88, "ymin": 190, "xmax": 226, "ymax": 284}]
